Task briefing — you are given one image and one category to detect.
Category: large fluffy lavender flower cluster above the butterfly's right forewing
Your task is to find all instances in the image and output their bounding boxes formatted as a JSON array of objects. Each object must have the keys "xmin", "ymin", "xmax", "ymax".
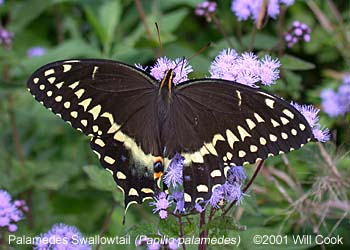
[{"xmin": 209, "ymin": 49, "xmax": 280, "ymax": 87}]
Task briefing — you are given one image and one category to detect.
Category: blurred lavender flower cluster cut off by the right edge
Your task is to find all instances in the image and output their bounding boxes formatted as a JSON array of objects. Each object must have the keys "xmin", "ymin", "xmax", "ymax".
[{"xmin": 321, "ymin": 74, "xmax": 350, "ymax": 117}]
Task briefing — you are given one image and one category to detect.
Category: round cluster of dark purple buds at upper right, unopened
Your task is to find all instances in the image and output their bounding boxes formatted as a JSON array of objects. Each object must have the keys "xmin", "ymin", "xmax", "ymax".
[{"xmin": 284, "ymin": 21, "xmax": 311, "ymax": 48}]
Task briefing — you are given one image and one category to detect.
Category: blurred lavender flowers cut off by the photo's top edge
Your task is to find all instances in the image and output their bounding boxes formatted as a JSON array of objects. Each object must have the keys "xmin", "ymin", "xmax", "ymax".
[{"xmin": 231, "ymin": 0, "xmax": 294, "ymax": 21}]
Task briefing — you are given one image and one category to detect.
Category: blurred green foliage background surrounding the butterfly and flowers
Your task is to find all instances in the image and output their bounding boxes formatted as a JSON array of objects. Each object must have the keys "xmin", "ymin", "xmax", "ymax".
[{"xmin": 0, "ymin": 0, "xmax": 350, "ymax": 249}]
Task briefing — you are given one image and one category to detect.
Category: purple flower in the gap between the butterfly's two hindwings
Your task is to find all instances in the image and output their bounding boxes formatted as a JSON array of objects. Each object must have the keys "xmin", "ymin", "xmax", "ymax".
[{"xmin": 164, "ymin": 153, "xmax": 185, "ymax": 188}]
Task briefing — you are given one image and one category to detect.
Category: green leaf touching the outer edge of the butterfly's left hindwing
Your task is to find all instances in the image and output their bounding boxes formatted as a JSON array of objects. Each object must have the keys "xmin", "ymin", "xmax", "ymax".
[{"xmin": 83, "ymin": 165, "xmax": 116, "ymax": 192}]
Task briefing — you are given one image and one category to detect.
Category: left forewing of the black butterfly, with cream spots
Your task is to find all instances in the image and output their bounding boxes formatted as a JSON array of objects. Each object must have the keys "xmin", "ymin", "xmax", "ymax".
[{"xmin": 28, "ymin": 60, "xmax": 157, "ymax": 140}]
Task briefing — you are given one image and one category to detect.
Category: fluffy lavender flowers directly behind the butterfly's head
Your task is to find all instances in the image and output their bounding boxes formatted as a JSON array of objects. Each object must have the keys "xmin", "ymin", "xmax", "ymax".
[{"xmin": 145, "ymin": 57, "xmax": 193, "ymax": 84}]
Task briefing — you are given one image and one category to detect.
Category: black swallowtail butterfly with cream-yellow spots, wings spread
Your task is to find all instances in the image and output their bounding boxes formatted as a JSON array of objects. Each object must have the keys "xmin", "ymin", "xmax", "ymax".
[{"xmin": 28, "ymin": 59, "xmax": 314, "ymax": 209}]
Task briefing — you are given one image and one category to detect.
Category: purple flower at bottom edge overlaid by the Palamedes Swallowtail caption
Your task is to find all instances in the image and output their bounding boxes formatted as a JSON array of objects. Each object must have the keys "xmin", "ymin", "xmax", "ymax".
[{"xmin": 33, "ymin": 223, "xmax": 91, "ymax": 250}]
